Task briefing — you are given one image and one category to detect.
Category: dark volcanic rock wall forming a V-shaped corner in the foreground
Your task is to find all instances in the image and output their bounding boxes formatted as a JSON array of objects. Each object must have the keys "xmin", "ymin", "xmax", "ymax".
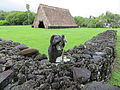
[{"xmin": 0, "ymin": 30, "xmax": 120, "ymax": 90}]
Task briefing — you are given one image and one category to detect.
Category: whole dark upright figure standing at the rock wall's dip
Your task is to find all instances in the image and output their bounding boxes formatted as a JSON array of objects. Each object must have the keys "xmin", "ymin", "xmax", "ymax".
[{"xmin": 48, "ymin": 35, "xmax": 66, "ymax": 63}]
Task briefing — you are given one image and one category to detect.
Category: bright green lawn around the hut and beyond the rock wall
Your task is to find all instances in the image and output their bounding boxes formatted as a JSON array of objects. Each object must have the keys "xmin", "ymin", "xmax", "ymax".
[{"xmin": 0, "ymin": 26, "xmax": 120, "ymax": 86}]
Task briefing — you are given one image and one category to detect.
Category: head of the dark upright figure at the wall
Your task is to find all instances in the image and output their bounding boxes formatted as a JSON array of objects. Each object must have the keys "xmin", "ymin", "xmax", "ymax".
[{"xmin": 50, "ymin": 35, "xmax": 66, "ymax": 50}]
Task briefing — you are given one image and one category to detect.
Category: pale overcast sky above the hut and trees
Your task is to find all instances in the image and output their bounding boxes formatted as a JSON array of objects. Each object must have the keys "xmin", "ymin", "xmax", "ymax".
[{"xmin": 0, "ymin": 0, "xmax": 120, "ymax": 17}]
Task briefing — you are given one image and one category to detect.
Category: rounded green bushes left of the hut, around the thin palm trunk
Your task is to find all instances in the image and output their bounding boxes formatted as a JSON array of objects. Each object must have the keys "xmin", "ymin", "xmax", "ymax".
[{"xmin": 6, "ymin": 11, "xmax": 35, "ymax": 25}]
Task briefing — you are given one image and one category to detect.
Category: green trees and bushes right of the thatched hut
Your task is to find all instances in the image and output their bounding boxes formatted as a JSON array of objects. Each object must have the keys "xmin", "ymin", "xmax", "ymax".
[{"xmin": 74, "ymin": 12, "xmax": 120, "ymax": 28}]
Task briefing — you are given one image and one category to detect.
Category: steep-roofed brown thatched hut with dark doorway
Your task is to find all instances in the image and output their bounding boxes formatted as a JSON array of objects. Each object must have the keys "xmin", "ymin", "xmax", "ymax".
[{"xmin": 32, "ymin": 4, "xmax": 77, "ymax": 28}]
